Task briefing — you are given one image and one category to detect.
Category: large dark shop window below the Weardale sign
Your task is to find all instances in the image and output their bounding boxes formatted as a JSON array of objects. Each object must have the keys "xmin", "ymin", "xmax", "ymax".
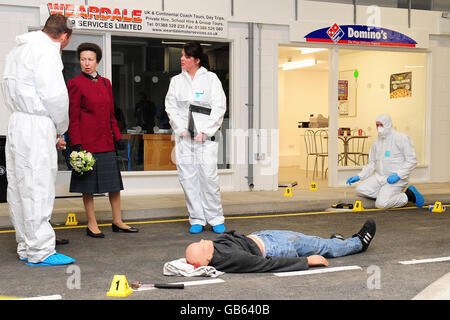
[{"xmin": 111, "ymin": 36, "xmax": 229, "ymax": 171}]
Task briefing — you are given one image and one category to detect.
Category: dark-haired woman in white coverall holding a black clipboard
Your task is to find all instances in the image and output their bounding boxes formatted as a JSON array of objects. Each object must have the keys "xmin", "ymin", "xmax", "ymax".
[{"xmin": 165, "ymin": 41, "xmax": 226, "ymax": 233}]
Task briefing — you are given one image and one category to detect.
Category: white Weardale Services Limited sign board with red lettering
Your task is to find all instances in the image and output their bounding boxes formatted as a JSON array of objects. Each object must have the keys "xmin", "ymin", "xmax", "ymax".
[{"xmin": 40, "ymin": 2, "xmax": 228, "ymax": 38}]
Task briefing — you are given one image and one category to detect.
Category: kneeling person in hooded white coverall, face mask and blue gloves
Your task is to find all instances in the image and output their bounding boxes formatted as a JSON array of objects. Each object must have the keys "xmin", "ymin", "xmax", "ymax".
[{"xmin": 347, "ymin": 114, "xmax": 424, "ymax": 208}]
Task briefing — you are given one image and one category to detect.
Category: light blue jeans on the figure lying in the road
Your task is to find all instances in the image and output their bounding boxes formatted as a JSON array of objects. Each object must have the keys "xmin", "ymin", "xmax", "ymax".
[{"xmin": 252, "ymin": 230, "xmax": 362, "ymax": 258}]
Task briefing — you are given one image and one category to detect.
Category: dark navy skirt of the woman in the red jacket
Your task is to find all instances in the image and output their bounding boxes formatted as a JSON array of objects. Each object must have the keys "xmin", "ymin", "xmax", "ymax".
[{"xmin": 69, "ymin": 151, "xmax": 123, "ymax": 194}]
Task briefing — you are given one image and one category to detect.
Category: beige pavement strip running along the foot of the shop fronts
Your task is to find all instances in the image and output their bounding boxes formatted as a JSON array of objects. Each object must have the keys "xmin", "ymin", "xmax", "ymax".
[{"xmin": 0, "ymin": 183, "xmax": 450, "ymax": 228}]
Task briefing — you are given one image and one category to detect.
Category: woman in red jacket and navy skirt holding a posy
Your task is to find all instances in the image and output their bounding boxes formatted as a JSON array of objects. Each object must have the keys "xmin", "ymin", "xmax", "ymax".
[{"xmin": 67, "ymin": 43, "xmax": 138, "ymax": 238}]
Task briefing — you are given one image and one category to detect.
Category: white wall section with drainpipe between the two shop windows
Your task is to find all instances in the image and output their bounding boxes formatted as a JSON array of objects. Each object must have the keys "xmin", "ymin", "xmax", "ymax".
[{"xmin": 229, "ymin": 23, "xmax": 289, "ymax": 191}]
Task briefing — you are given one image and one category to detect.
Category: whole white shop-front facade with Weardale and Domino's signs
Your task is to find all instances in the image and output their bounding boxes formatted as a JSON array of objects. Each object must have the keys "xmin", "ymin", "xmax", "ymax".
[{"xmin": 0, "ymin": 0, "xmax": 450, "ymax": 196}]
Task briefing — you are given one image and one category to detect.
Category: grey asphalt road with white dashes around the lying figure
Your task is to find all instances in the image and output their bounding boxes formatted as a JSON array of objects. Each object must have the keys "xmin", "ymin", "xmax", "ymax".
[{"xmin": 0, "ymin": 209, "xmax": 450, "ymax": 313}]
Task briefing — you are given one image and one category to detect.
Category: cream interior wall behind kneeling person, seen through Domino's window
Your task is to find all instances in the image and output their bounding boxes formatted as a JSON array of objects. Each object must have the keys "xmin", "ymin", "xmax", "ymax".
[{"xmin": 339, "ymin": 51, "xmax": 427, "ymax": 164}]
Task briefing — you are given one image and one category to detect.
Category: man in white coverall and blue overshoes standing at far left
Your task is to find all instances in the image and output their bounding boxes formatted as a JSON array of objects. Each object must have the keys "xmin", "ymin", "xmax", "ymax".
[{"xmin": 2, "ymin": 15, "xmax": 75, "ymax": 266}]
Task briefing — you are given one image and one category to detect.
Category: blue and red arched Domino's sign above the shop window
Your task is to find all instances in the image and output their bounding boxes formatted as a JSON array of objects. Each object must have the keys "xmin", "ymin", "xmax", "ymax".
[{"xmin": 305, "ymin": 23, "xmax": 417, "ymax": 47}]
